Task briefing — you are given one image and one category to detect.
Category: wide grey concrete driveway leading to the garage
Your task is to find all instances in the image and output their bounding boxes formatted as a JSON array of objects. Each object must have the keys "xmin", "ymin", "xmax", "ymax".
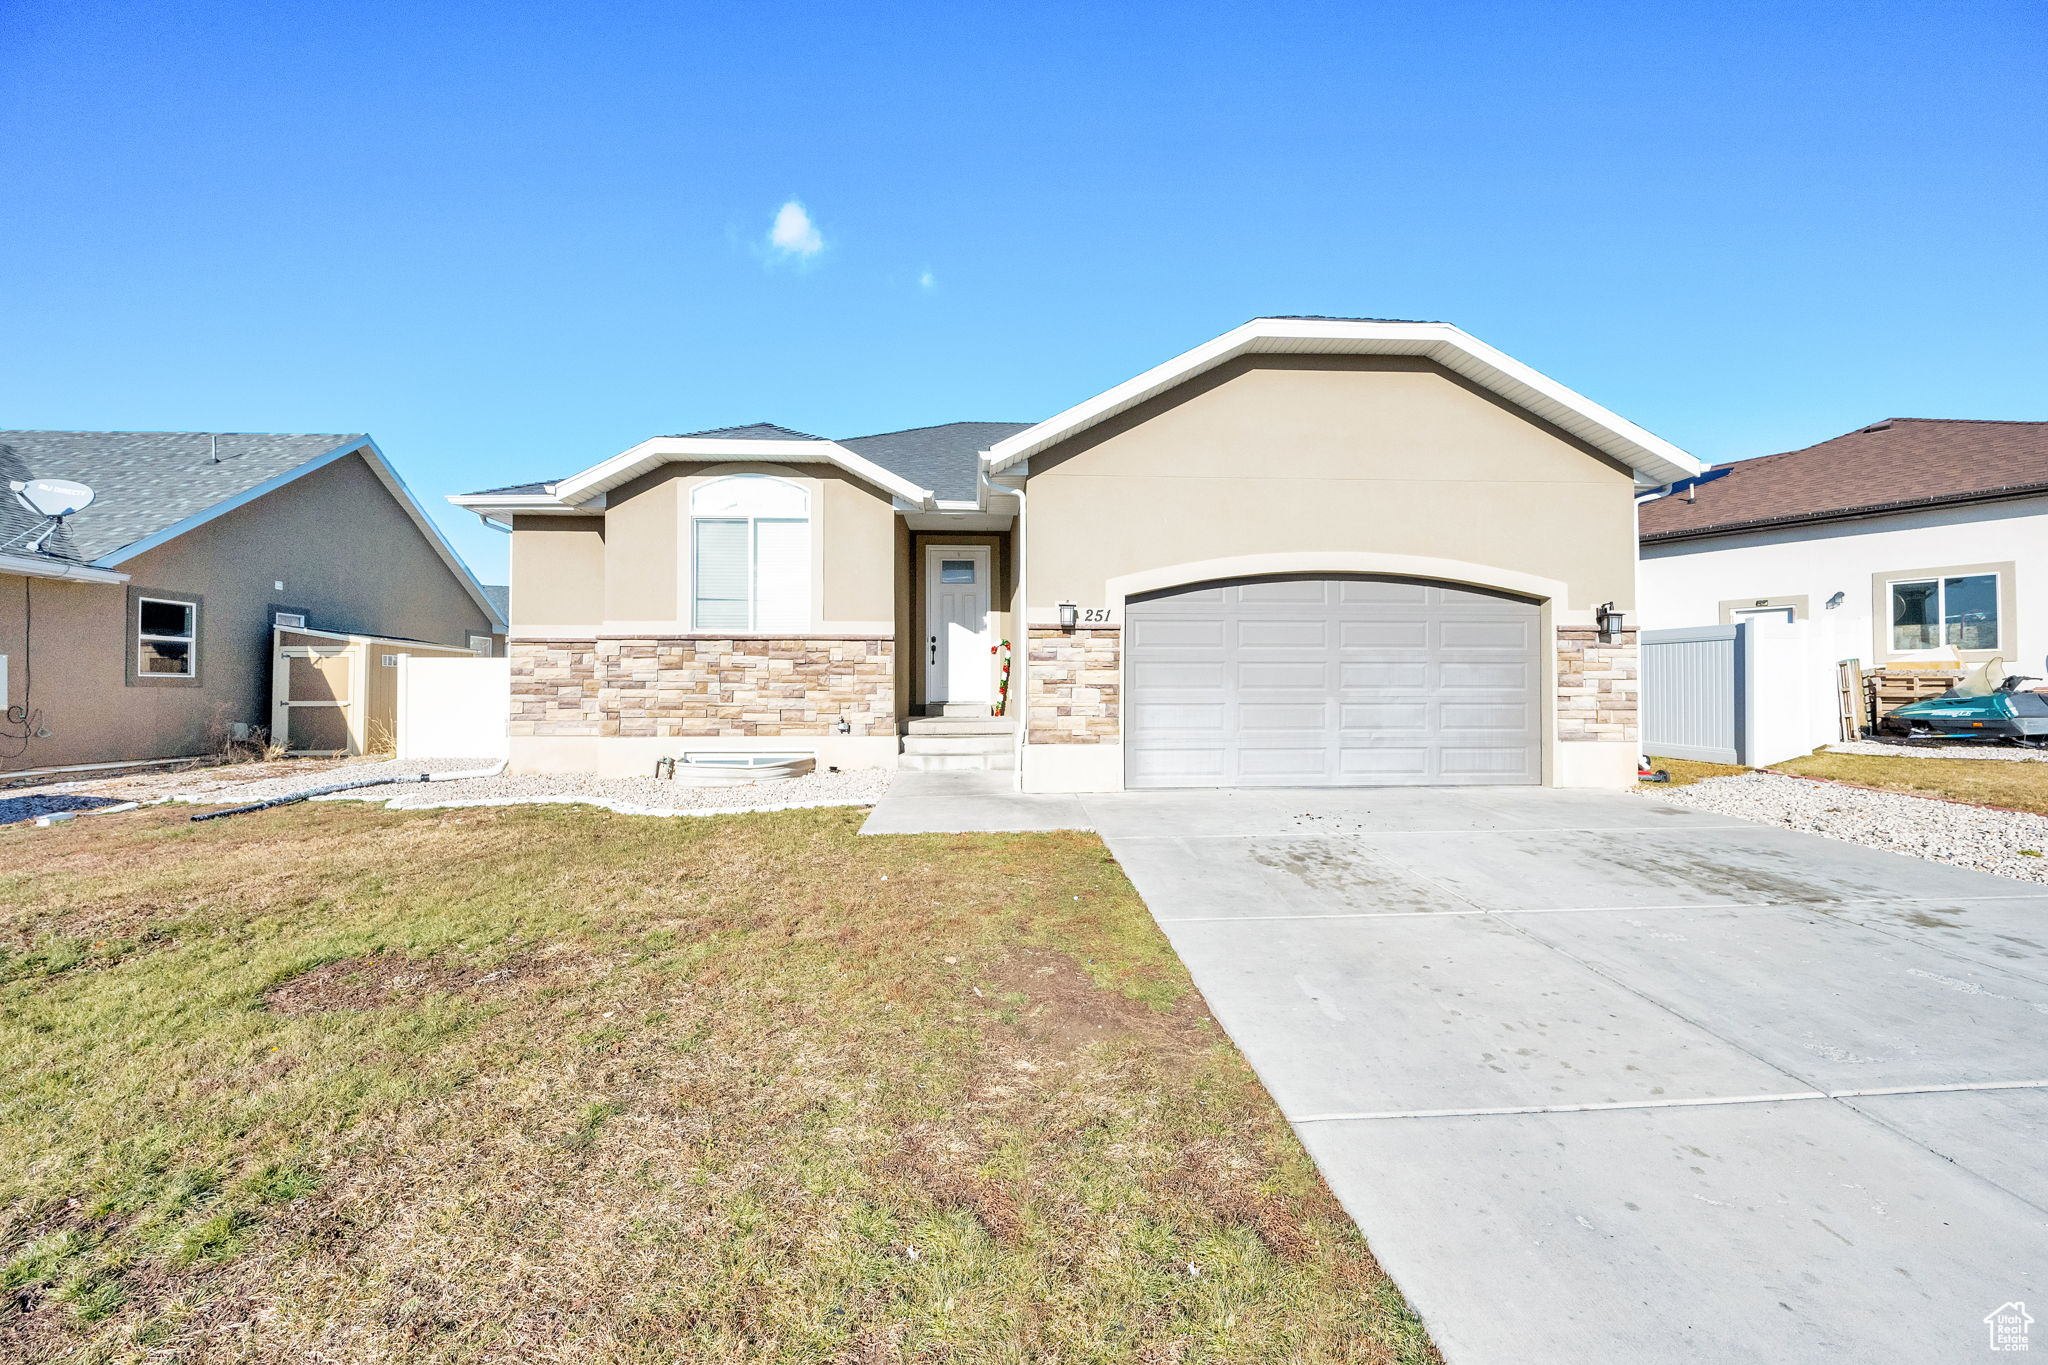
[{"xmin": 1081, "ymin": 788, "xmax": 2048, "ymax": 1365}]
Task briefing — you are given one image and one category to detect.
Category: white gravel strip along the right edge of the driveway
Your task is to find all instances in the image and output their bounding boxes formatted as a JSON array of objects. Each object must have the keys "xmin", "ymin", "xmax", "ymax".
[{"xmin": 1638, "ymin": 772, "xmax": 2048, "ymax": 882}]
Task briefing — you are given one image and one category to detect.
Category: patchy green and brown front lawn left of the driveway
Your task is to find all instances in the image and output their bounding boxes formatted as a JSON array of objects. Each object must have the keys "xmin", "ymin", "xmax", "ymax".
[{"xmin": 0, "ymin": 804, "xmax": 1436, "ymax": 1365}]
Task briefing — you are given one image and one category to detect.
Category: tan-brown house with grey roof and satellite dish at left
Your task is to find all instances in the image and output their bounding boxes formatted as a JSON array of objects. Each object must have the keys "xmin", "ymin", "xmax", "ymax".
[{"xmin": 0, "ymin": 432, "xmax": 504, "ymax": 772}]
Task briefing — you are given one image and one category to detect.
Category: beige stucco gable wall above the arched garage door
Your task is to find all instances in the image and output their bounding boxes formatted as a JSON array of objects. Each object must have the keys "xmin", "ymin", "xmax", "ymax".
[{"xmin": 1028, "ymin": 356, "xmax": 1634, "ymax": 620}]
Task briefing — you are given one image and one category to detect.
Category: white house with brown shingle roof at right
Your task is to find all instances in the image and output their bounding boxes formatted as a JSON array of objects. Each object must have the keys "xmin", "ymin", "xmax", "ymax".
[{"xmin": 1640, "ymin": 417, "xmax": 2048, "ymax": 673}]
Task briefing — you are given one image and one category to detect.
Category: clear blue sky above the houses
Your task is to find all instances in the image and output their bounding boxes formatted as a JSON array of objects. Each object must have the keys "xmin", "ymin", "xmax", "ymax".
[{"xmin": 0, "ymin": 0, "xmax": 2048, "ymax": 579}]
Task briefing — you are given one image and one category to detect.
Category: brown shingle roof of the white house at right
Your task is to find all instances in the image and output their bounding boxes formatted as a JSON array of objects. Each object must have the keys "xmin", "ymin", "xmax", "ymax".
[{"xmin": 1638, "ymin": 417, "xmax": 2048, "ymax": 542}]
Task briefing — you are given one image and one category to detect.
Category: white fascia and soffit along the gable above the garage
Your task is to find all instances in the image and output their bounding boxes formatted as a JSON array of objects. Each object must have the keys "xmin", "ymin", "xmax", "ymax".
[{"xmin": 981, "ymin": 317, "xmax": 1702, "ymax": 483}]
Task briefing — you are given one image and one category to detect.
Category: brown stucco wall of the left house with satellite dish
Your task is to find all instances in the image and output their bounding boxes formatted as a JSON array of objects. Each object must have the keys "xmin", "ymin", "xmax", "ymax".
[{"xmin": 0, "ymin": 456, "xmax": 494, "ymax": 772}]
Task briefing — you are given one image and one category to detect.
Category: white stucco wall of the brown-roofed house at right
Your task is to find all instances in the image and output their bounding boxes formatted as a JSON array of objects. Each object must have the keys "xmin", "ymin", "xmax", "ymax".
[{"xmin": 1638, "ymin": 497, "xmax": 2048, "ymax": 673}]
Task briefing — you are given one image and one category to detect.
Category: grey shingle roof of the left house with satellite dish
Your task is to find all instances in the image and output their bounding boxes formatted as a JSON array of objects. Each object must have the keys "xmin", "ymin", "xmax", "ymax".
[{"xmin": 0, "ymin": 432, "xmax": 504, "ymax": 626}]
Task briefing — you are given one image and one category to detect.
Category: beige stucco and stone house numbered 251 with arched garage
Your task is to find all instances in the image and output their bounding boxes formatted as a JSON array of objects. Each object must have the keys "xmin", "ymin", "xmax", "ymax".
[{"xmin": 455, "ymin": 317, "xmax": 1700, "ymax": 792}]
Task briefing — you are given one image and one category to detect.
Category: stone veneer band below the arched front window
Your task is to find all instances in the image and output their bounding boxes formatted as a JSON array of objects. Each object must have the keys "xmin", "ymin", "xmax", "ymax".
[{"xmin": 510, "ymin": 634, "xmax": 897, "ymax": 739}]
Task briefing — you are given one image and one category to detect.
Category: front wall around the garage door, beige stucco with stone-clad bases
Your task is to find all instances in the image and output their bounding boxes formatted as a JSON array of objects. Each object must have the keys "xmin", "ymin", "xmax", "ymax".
[{"xmin": 1022, "ymin": 356, "xmax": 1636, "ymax": 792}]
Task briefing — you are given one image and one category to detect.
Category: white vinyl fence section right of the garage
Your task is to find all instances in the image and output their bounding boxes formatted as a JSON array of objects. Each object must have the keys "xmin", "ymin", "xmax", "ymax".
[{"xmin": 1640, "ymin": 620, "xmax": 1841, "ymax": 767}]
